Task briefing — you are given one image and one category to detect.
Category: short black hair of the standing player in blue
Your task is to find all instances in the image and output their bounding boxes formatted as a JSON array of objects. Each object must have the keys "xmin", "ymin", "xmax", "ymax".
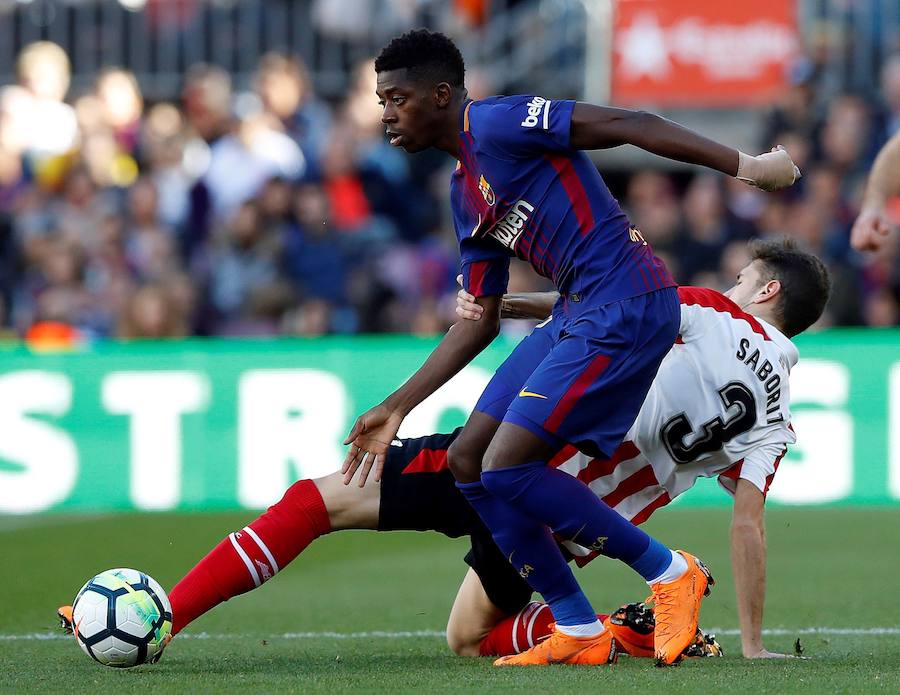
[{"xmin": 375, "ymin": 29, "xmax": 466, "ymax": 87}]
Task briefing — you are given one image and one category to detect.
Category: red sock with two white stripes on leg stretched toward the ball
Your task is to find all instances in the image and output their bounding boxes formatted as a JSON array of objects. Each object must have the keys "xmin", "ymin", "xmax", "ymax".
[{"xmin": 169, "ymin": 480, "xmax": 331, "ymax": 635}]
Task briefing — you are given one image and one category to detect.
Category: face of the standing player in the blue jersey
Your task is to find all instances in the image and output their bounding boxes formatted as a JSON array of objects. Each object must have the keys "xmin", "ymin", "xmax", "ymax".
[{"xmin": 375, "ymin": 70, "xmax": 439, "ymax": 152}]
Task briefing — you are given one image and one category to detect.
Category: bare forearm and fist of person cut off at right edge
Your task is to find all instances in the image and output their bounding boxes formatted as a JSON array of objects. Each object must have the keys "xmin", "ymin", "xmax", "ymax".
[{"xmin": 850, "ymin": 133, "xmax": 900, "ymax": 251}]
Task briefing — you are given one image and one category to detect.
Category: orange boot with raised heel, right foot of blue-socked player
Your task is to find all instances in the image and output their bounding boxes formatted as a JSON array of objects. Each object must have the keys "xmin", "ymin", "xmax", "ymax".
[{"xmin": 647, "ymin": 550, "xmax": 716, "ymax": 666}]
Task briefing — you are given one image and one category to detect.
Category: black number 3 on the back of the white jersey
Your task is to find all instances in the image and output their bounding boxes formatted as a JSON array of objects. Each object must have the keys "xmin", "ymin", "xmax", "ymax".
[{"xmin": 660, "ymin": 381, "xmax": 756, "ymax": 463}]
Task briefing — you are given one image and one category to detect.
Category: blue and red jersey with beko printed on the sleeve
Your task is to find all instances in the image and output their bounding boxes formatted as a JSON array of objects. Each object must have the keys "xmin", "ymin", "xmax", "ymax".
[{"xmin": 450, "ymin": 96, "xmax": 675, "ymax": 306}]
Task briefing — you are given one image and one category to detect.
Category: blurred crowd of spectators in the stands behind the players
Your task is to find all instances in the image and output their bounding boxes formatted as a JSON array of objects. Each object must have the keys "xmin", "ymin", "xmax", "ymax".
[{"xmin": 0, "ymin": 25, "xmax": 900, "ymax": 340}]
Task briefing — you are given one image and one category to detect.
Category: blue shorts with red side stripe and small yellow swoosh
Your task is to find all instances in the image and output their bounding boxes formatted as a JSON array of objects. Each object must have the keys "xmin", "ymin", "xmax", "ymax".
[{"xmin": 475, "ymin": 287, "xmax": 681, "ymax": 458}]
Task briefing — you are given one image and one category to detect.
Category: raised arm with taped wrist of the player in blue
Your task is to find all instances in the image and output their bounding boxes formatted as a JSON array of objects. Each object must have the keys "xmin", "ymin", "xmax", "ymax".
[{"xmin": 570, "ymin": 102, "xmax": 800, "ymax": 191}]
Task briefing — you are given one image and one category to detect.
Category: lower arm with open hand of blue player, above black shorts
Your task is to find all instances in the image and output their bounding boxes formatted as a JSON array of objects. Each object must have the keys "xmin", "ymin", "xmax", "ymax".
[{"xmin": 341, "ymin": 296, "xmax": 500, "ymax": 487}]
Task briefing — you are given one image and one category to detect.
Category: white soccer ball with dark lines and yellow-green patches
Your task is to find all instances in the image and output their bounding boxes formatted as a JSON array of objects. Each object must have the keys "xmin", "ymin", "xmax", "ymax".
[{"xmin": 72, "ymin": 568, "xmax": 172, "ymax": 668}]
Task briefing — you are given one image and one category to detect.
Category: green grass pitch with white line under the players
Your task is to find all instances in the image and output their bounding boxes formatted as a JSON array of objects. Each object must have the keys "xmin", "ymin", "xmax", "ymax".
[{"xmin": 0, "ymin": 509, "xmax": 900, "ymax": 695}]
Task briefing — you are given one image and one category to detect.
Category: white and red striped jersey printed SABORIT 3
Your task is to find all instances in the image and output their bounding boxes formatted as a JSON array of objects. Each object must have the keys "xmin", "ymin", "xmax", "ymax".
[{"xmin": 552, "ymin": 287, "xmax": 799, "ymax": 554}]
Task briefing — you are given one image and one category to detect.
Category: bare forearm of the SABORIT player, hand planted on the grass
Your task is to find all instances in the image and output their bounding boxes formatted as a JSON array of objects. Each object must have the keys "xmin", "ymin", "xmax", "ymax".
[{"xmin": 731, "ymin": 479, "xmax": 787, "ymax": 659}]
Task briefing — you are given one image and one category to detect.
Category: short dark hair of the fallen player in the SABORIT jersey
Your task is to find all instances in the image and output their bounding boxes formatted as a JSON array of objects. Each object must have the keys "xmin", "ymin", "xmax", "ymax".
[{"xmin": 750, "ymin": 239, "xmax": 831, "ymax": 337}]
